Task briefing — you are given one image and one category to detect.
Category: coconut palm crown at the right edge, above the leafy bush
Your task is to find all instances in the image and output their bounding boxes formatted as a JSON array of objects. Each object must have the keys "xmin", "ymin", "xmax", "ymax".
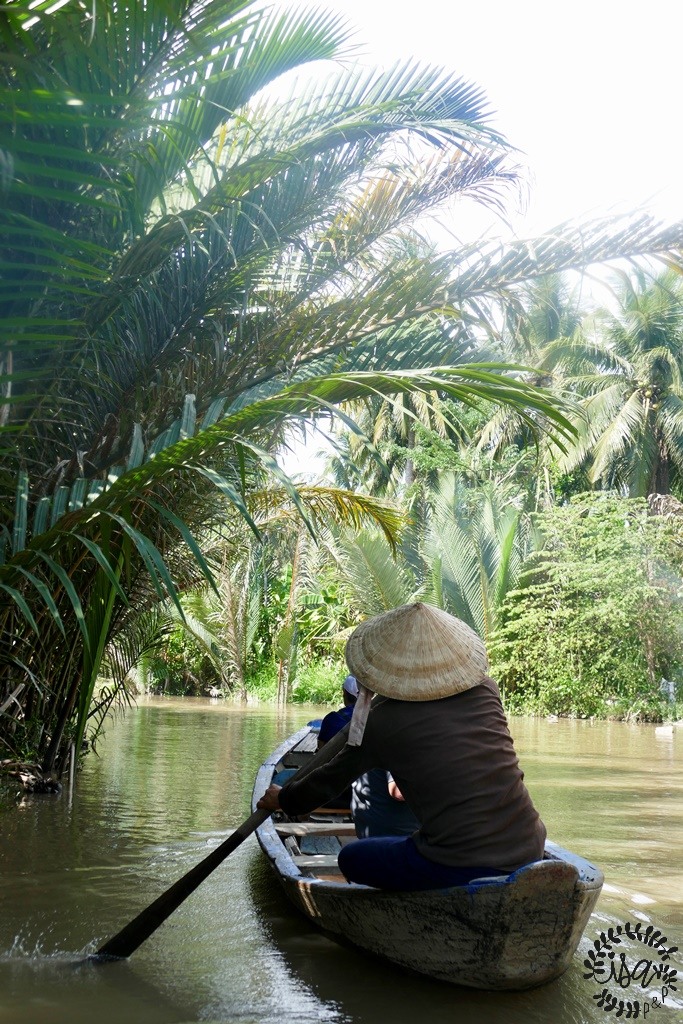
[{"xmin": 563, "ymin": 269, "xmax": 683, "ymax": 498}]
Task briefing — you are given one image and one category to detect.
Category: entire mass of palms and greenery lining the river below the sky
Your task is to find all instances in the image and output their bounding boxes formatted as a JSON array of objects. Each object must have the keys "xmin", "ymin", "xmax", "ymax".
[{"xmin": 0, "ymin": 0, "xmax": 683, "ymax": 773}]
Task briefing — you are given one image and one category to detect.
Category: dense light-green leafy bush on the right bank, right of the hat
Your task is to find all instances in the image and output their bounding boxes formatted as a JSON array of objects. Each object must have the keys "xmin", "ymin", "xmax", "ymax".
[{"xmin": 489, "ymin": 495, "xmax": 683, "ymax": 720}]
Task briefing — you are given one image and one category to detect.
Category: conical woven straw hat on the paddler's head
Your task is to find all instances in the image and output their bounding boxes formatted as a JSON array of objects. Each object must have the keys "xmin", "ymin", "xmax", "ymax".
[{"xmin": 346, "ymin": 602, "xmax": 488, "ymax": 700}]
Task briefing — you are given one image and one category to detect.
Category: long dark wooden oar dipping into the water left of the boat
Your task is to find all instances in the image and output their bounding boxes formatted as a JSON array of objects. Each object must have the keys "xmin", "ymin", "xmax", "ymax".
[{"xmin": 88, "ymin": 726, "xmax": 348, "ymax": 963}]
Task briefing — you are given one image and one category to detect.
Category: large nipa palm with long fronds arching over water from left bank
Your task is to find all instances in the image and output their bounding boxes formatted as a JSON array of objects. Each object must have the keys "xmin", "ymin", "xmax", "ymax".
[{"xmin": 5, "ymin": 0, "xmax": 683, "ymax": 770}]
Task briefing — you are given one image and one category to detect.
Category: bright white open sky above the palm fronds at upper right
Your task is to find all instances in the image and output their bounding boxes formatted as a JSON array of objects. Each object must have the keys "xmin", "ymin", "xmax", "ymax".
[{"xmin": 288, "ymin": 0, "xmax": 683, "ymax": 237}]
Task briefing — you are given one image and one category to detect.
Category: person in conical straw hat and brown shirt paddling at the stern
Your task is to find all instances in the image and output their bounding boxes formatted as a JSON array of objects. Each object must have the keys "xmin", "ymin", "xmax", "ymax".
[{"xmin": 258, "ymin": 603, "xmax": 546, "ymax": 891}]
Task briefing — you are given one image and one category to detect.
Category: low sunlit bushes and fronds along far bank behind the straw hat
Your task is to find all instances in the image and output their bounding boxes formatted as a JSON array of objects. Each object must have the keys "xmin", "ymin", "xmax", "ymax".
[{"xmin": 143, "ymin": 479, "xmax": 683, "ymax": 722}]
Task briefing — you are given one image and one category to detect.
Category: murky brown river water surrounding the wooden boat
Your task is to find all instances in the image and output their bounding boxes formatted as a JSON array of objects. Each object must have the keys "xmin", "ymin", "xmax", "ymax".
[{"xmin": 0, "ymin": 698, "xmax": 683, "ymax": 1024}]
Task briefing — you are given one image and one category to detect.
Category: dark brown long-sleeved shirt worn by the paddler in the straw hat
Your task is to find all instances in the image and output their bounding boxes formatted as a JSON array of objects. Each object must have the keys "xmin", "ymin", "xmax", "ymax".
[{"xmin": 280, "ymin": 679, "xmax": 546, "ymax": 871}]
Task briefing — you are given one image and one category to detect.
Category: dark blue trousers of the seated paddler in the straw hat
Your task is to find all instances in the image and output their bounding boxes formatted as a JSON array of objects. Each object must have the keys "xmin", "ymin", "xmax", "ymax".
[{"xmin": 339, "ymin": 836, "xmax": 510, "ymax": 892}]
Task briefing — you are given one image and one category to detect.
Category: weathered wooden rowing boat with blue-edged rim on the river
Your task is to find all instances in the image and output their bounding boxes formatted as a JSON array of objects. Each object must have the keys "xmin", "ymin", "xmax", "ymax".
[{"xmin": 253, "ymin": 727, "xmax": 603, "ymax": 989}]
